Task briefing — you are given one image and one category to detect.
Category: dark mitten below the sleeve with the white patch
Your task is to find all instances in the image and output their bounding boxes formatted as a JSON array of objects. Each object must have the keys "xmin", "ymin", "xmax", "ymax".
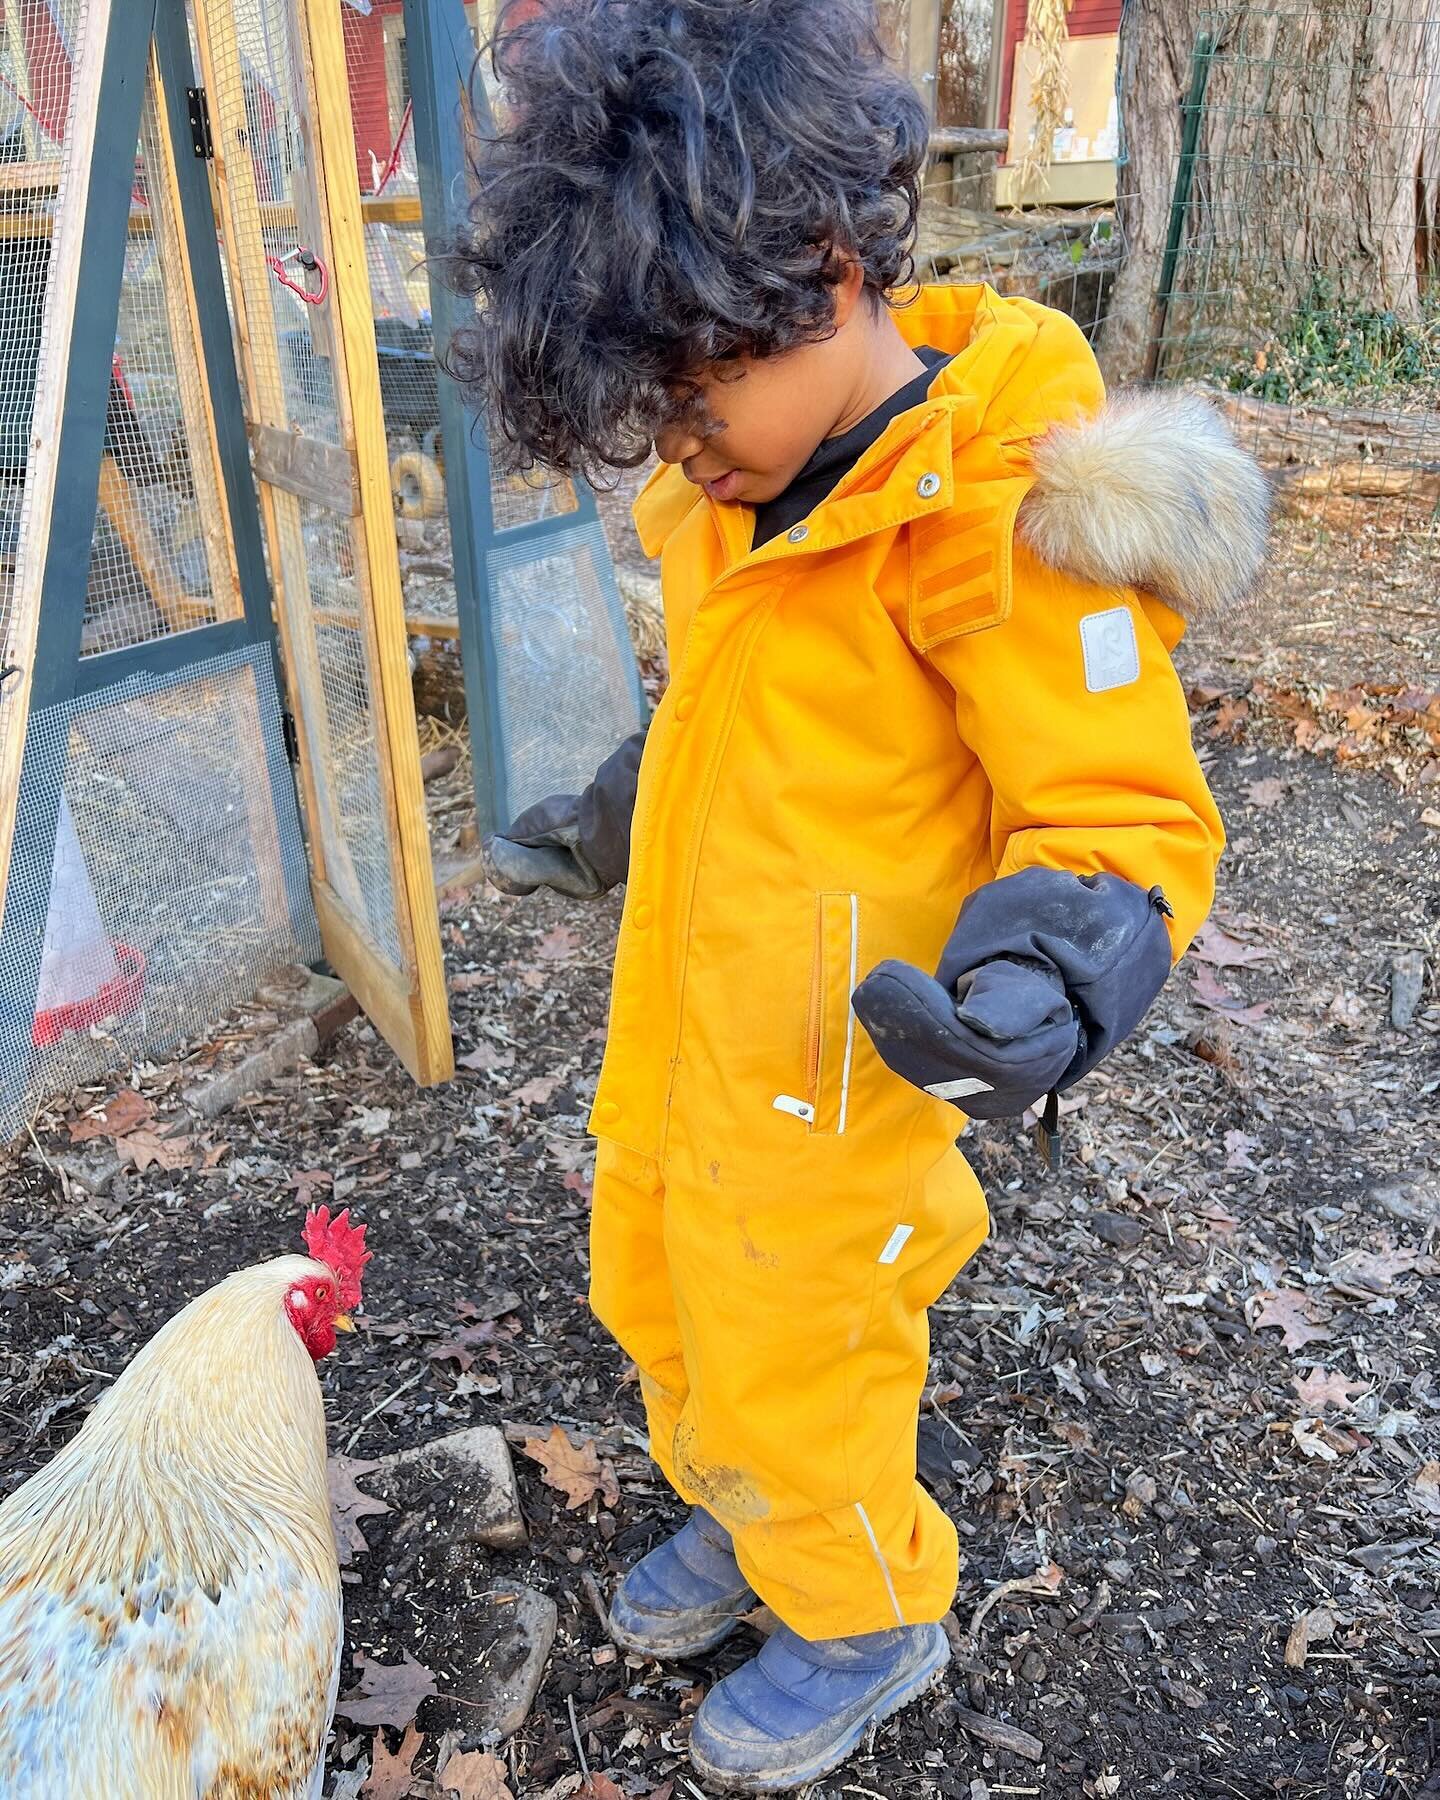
[{"xmin": 855, "ymin": 868, "xmax": 1170, "ymax": 1118}]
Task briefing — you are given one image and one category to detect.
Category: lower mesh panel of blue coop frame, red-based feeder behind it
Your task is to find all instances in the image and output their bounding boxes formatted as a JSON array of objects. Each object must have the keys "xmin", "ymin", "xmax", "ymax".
[{"xmin": 0, "ymin": 646, "xmax": 320, "ymax": 1136}]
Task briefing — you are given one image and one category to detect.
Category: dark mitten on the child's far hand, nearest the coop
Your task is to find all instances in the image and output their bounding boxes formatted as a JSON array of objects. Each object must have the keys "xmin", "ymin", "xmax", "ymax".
[{"xmin": 481, "ymin": 731, "xmax": 644, "ymax": 900}]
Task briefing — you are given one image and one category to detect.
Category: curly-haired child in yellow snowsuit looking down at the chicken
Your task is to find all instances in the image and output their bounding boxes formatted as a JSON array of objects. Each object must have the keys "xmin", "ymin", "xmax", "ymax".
[{"xmin": 455, "ymin": 0, "xmax": 1265, "ymax": 1791}]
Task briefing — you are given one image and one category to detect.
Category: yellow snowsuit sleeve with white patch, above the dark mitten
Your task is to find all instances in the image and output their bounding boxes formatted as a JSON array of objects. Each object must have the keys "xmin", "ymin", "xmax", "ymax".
[{"xmin": 927, "ymin": 536, "xmax": 1224, "ymax": 956}]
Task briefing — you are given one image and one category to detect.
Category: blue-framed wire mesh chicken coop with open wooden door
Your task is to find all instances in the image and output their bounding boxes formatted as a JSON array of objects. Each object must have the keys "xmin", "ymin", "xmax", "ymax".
[{"xmin": 0, "ymin": 0, "xmax": 641, "ymax": 1134}]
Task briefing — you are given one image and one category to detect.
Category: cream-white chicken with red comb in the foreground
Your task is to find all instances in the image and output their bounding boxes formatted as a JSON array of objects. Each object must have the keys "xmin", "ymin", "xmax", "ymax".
[{"xmin": 0, "ymin": 1208, "xmax": 369, "ymax": 1800}]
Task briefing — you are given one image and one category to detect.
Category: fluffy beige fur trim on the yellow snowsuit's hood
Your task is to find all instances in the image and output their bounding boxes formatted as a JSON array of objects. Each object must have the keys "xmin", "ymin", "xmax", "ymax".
[{"xmin": 1017, "ymin": 389, "xmax": 1271, "ymax": 619}]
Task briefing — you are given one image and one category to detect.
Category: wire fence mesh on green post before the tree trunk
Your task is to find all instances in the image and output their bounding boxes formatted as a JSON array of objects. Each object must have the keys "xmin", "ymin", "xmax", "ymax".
[{"xmin": 1154, "ymin": 0, "xmax": 1440, "ymax": 572}]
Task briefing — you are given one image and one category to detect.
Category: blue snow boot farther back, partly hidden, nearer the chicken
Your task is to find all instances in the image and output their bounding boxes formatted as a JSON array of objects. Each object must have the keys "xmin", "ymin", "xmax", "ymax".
[{"xmin": 610, "ymin": 1507, "xmax": 754, "ymax": 1658}]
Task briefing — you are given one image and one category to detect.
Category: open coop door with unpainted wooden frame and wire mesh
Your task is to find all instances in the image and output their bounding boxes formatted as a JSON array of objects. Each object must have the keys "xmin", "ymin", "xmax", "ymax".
[{"xmin": 194, "ymin": 0, "xmax": 454, "ymax": 1082}]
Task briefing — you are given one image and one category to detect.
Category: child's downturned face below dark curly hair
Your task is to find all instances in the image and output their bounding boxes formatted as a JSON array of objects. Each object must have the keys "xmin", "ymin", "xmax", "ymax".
[{"xmin": 655, "ymin": 265, "xmax": 878, "ymax": 506}]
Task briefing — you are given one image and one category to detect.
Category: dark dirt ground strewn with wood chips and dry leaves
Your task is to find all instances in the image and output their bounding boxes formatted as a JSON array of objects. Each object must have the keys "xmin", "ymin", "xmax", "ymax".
[{"xmin": 0, "ymin": 511, "xmax": 1440, "ymax": 1800}]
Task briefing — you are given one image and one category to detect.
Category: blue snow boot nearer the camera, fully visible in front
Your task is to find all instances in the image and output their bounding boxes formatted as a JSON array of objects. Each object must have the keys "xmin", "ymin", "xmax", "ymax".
[{"xmin": 689, "ymin": 1625, "xmax": 950, "ymax": 1795}]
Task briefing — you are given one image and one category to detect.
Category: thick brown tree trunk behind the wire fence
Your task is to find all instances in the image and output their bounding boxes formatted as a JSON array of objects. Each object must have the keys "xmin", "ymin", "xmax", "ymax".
[{"xmin": 1102, "ymin": 0, "xmax": 1440, "ymax": 380}]
